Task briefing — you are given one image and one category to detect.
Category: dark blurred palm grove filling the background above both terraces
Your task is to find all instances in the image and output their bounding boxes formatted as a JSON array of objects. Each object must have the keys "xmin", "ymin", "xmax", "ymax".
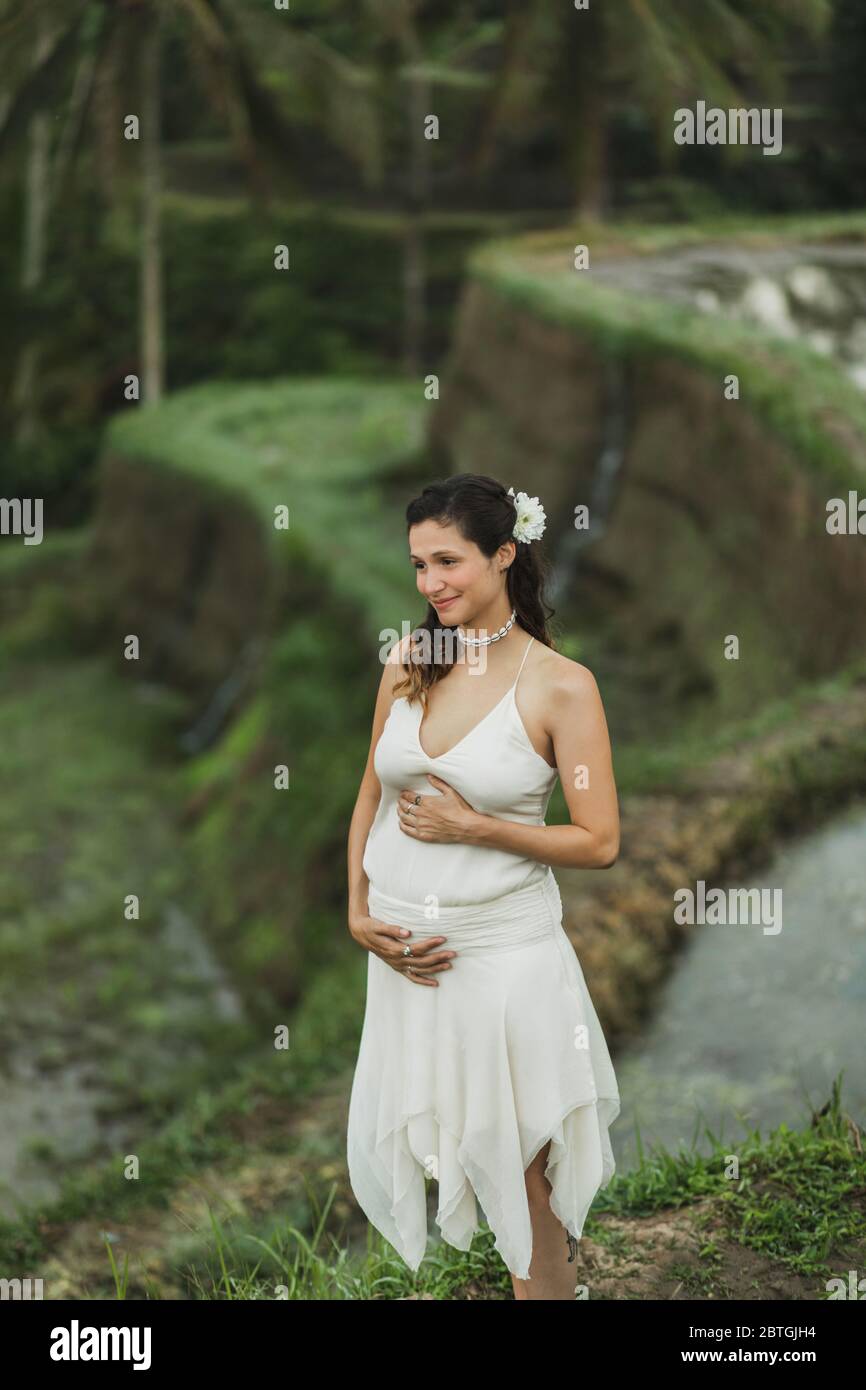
[{"xmin": 0, "ymin": 0, "xmax": 866, "ymax": 505}]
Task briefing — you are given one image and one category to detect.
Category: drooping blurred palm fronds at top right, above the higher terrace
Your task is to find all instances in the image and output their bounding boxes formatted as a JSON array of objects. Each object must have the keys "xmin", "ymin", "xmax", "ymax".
[{"xmin": 470, "ymin": 0, "xmax": 831, "ymax": 218}]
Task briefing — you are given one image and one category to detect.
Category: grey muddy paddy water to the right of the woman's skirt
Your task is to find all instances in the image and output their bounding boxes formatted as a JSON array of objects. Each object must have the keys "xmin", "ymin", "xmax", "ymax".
[{"xmin": 610, "ymin": 802, "xmax": 866, "ymax": 1169}]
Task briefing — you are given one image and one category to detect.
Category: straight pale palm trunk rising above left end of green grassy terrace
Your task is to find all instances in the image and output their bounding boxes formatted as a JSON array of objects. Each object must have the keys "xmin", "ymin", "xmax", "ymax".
[{"xmin": 140, "ymin": 7, "xmax": 165, "ymax": 403}]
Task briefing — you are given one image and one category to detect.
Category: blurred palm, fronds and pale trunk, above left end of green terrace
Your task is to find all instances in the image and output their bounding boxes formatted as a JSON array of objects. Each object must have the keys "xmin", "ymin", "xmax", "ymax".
[{"xmin": 0, "ymin": 0, "xmax": 379, "ymax": 409}]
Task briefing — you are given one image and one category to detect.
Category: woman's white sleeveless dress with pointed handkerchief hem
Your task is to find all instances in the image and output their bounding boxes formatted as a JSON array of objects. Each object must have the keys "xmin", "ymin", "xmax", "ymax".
[{"xmin": 346, "ymin": 638, "xmax": 620, "ymax": 1279}]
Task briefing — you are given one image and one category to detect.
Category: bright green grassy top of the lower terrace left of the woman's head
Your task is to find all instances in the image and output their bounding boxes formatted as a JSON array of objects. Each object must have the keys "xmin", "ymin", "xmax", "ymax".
[{"xmin": 106, "ymin": 378, "xmax": 430, "ymax": 634}]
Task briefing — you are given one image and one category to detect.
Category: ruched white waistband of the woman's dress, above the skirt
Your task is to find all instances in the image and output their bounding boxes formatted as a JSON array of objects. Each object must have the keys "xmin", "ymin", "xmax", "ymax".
[{"xmin": 367, "ymin": 872, "xmax": 562, "ymax": 954}]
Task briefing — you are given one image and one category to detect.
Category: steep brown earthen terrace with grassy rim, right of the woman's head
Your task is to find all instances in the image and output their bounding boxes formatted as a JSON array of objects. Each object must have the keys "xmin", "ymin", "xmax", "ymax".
[{"xmin": 434, "ymin": 215, "xmax": 866, "ymax": 734}]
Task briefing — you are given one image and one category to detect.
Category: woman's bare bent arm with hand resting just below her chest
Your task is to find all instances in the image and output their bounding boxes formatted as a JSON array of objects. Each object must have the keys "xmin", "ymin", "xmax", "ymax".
[{"xmin": 398, "ymin": 664, "xmax": 620, "ymax": 869}]
